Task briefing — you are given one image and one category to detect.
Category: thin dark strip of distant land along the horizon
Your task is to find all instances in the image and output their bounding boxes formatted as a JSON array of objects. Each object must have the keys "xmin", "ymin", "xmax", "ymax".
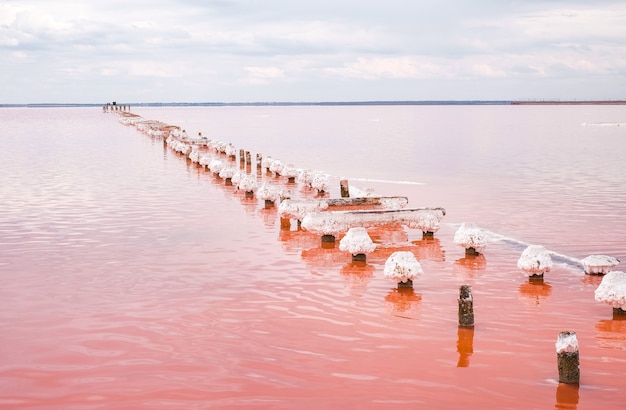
[{"xmin": 0, "ymin": 100, "xmax": 626, "ymax": 108}]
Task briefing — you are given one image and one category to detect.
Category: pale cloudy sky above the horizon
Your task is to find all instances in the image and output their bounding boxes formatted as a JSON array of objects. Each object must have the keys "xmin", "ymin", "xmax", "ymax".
[{"xmin": 0, "ymin": 0, "xmax": 626, "ymax": 103}]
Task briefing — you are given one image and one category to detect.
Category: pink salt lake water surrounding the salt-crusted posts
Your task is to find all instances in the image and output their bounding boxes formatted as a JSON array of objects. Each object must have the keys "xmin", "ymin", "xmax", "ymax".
[{"xmin": 0, "ymin": 106, "xmax": 626, "ymax": 409}]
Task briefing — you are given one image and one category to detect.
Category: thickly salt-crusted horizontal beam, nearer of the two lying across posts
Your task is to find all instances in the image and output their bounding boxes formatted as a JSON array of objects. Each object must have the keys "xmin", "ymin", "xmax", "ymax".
[{"xmin": 302, "ymin": 207, "xmax": 446, "ymax": 236}]
